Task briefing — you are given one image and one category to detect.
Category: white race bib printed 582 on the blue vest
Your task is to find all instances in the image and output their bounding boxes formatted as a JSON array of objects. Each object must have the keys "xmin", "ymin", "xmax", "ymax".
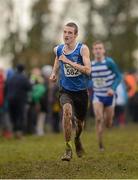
[{"xmin": 64, "ymin": 64, "xmax": 81, "ymax": 77}]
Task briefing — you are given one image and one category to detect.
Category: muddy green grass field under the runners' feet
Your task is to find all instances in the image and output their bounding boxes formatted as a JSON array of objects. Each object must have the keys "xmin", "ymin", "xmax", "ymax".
[{"xmin": 0, "ymin": 125, "xmax": 138, "ymax": 179}]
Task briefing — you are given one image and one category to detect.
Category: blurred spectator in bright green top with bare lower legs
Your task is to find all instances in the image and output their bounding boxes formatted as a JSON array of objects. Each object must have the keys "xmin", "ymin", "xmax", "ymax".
[{"xmin": 28, "ymin": 68, "xmax": 47, "ymax": 136}]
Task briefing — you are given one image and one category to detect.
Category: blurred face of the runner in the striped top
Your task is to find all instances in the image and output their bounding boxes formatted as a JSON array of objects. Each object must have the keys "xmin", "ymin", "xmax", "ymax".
[{"xmin": 92, "ymin": 44, "xmax": 105, "ymax": 58}]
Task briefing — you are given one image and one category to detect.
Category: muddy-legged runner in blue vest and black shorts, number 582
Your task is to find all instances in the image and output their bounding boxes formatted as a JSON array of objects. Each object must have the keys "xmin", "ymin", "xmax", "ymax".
[{"xmin": 50, "ymin": 22, "xmax": 91, "ymax": 161}]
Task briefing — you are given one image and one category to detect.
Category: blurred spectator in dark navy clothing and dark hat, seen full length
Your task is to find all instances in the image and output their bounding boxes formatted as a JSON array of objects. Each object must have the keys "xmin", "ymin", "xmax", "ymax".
[{"xmin": 6, "ymin": 64, "xmax": 31, "ymax": 138}]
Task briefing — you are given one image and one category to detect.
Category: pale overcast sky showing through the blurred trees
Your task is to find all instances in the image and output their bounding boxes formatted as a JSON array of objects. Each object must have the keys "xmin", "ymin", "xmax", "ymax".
[{"xmin": 0, "ymin": 0, "xmax": 107, "ymax": 66}]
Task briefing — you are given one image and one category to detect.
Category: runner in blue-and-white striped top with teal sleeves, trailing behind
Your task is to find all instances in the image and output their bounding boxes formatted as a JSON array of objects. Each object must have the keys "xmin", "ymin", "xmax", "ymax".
[{"xmin": 91, "ymin": 41, "xmax": 121, "ymax": 151}]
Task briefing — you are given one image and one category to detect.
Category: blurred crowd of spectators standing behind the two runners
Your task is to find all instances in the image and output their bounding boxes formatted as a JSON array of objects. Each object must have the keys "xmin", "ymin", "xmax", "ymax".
[{"xmin": 0, "ymin": 64, "xmax": 138, "ymax": 139}]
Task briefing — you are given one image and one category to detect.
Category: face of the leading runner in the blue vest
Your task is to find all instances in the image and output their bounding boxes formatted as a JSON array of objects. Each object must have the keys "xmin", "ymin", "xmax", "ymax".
[{"xmin": 63, "ymin": 26, "xmax": 77, "ymax": 44}]
